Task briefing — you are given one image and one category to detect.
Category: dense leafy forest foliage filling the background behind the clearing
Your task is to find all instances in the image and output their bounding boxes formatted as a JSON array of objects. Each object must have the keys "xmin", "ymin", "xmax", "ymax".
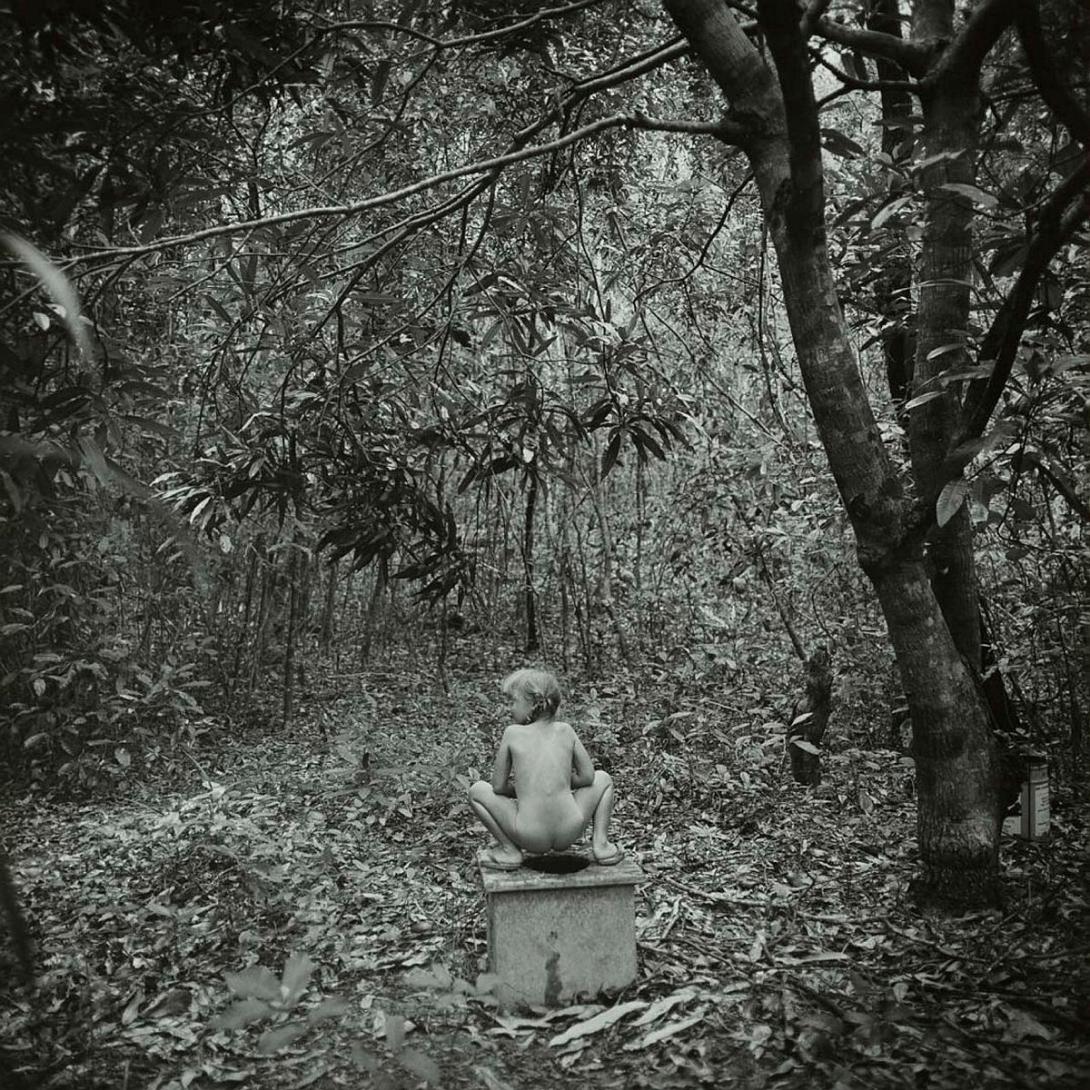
[{"xmin": 0, "ymin": 2, "xmax": 1088, "ymax": 776}]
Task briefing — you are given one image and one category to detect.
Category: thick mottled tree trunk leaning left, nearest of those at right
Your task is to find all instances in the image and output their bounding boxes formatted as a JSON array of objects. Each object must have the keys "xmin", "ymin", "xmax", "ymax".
[{"xmin": 666, "ymin": 0, "xmax": 1000, "ymax": 906}]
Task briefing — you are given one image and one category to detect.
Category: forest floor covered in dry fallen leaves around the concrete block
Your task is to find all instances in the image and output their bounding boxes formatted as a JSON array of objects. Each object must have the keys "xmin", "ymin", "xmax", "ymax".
[{"xmin": 0, "ymin": 649, "xmax": 1090, "ymax": 1090}]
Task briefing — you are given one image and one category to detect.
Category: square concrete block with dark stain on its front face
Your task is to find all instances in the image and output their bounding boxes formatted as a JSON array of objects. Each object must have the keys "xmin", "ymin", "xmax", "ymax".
[{"xmin": 481, "ymin": 859, "xmax": 644, "ymax": 1006}]
